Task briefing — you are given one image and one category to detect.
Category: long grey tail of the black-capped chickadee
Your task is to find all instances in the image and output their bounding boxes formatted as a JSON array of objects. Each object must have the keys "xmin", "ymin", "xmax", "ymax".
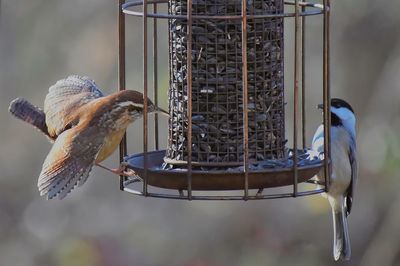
[{"xmin": 332, "ymin": 198, "xmax": 351, "ymax": 260}]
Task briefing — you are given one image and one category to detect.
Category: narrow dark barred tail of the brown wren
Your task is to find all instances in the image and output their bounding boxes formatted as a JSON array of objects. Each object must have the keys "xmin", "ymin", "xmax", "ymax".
[{"xmin": 8, "ymin": 98, "xmax": 54, "ymax": 140}]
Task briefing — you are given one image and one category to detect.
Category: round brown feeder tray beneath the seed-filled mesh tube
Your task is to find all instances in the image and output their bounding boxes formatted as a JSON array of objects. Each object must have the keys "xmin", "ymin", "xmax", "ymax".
[{"xmin": 125, "ymin": 150, "xmax": 323, "ymax": 190}]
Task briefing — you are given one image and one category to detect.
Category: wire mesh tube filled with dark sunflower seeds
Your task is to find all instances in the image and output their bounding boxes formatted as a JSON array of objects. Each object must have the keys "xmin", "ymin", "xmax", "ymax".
[{"xmin": 166, "ymin": 0, "xmax": 286, "ymax": 166}]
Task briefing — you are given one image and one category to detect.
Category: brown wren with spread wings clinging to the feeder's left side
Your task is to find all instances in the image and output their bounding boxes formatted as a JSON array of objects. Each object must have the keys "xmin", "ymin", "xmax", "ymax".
[{"xmin": 9, "ymin": 76, "xmax": 168, "ymax": 199}]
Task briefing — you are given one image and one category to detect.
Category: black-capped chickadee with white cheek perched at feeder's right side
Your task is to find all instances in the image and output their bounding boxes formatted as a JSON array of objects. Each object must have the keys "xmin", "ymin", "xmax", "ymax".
[{"xmin": 312, "ymin": 98, "xmax": 358, "ymax": 260}]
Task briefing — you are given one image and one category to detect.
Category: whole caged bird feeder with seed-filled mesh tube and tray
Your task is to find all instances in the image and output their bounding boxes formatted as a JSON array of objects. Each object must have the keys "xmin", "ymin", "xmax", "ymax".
[{"xmin": 118, "ymin": 0, "xmax": 330, "ymax": 200}]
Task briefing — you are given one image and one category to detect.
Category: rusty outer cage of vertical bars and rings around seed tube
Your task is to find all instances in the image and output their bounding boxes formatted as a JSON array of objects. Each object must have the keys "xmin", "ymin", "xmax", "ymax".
[{"xmin": 118, "ymin": 0, "xmax": 331, "ymax": 200}]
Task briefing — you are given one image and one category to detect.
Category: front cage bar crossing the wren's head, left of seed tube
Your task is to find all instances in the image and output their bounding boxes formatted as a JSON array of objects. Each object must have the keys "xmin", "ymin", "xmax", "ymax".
[{"xmin": 142, "ymin": 0, "xmax": 148, "ymax": 196}]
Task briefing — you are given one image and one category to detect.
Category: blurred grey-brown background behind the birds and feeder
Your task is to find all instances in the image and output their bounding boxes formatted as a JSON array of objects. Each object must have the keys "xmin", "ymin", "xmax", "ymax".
[{"xmin": 0, "ymin": 0, "xmax": 400, "ymax": 266}]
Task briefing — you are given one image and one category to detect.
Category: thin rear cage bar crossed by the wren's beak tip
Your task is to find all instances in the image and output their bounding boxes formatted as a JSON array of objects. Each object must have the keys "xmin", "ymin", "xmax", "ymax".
[{"xmin": 153, "ymin": 3, "xmax": 159, "ymax": 150}]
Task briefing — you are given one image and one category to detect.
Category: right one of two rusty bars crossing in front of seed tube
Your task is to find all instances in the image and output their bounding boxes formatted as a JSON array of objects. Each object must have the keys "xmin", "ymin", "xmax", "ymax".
[{"xmin": 242, "ymin": 0, "xmax": 249, "ymax": 200}]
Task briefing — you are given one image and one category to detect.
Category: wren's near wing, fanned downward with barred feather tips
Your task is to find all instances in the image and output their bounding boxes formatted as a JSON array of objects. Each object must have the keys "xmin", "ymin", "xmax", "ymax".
[{"xmin": 38, "ymin": 120, "xmax": 103, "ymax": 199}]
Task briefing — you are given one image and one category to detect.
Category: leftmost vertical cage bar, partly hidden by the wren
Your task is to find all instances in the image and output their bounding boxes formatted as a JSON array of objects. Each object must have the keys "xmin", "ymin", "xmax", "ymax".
[{"xmin": 118, "ymin": 0, "xmax": 127, "ymax": 190}]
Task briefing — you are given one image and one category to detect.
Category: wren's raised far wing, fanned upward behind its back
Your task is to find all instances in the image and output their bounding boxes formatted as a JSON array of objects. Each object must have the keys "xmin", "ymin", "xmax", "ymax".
[{"xmin": 44, "ymin": 75, "xmax": 103, "ymax": 137}]
